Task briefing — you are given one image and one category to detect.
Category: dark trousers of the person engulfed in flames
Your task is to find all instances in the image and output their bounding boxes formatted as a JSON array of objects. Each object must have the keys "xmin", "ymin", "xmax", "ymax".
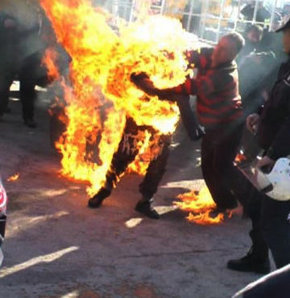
[{"xmin": 105, "ymin": 118, "xmax": 171, "ymax": 200}]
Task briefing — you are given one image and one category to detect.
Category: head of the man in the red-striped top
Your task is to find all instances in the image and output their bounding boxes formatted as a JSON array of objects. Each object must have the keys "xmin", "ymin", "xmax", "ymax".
[{"xmin": 212, "ymin": 32, "xmax": 245, "ymax": 67}]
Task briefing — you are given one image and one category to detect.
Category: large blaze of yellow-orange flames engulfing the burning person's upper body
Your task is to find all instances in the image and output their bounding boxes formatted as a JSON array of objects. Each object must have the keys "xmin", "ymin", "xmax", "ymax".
[{"xmin": 41, "ymin": 0, "xmax": 195, "ymax": 195}]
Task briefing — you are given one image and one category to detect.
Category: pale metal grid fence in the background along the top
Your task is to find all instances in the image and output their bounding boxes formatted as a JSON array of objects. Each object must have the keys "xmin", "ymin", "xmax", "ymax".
[{"xmin": 95, "ymin": 0, "xmax": 290, "ymax": 42}]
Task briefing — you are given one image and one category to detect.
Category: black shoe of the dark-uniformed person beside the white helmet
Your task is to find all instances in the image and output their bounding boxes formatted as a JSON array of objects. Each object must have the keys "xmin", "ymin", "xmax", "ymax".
[{"xmin": 227, "ymin": 250, "xmax": 271, "ymax": 274}]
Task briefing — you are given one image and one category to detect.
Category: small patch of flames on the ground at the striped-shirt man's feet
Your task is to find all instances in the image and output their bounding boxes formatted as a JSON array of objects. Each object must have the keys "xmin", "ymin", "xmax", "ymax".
[{"xmin": 175, "ymin": 187, "xmax": 224, "ymax": 225}]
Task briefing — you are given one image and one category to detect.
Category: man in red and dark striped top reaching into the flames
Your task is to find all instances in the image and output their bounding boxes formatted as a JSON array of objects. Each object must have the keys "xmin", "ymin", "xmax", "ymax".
[{"xmin": 131, "ymin": 32, "xmax": 256, "ymax": 211}]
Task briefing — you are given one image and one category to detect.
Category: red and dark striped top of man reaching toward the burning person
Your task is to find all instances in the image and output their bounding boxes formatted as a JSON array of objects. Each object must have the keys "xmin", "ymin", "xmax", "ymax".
[{"xmin": 158, "ymin": 48, "xmax": 243, "ymax": 128}]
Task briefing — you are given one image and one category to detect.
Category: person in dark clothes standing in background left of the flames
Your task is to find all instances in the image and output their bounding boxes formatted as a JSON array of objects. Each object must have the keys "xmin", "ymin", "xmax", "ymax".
[{"xmin": 0, "ymin": 10, "xmax": 53, "ymax": 128}]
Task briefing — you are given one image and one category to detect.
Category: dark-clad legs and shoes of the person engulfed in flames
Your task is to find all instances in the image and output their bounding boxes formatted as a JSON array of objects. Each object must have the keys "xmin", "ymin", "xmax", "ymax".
[{"xmin": 88, "ymin": 118, "xmax": 170, "ymax": 219}]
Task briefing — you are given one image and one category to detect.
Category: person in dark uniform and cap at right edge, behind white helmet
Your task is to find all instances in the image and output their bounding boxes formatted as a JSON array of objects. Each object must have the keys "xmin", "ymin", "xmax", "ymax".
[{"xmin": 228, "ymin": 18, "xmax": 290, "ymax": 272}]
